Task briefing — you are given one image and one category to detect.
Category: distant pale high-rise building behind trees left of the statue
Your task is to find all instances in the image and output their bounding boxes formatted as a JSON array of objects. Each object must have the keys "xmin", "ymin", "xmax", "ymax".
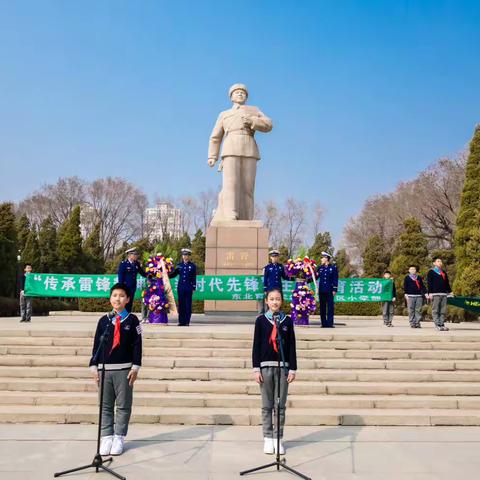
[{"xmin": 144, "ymin": 202, "xmax": 182, "ymax": 241}]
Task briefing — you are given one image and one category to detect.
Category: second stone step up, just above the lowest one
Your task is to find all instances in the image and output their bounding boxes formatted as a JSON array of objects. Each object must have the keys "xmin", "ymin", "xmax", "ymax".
[{"xmin": 0, "ymin": 391, "xmax": 480, "ymax": 410}]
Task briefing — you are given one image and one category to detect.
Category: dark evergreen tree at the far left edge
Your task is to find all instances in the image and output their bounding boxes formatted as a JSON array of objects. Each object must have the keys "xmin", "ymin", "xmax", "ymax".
[{"xmin": 0, "ymin": 202, "xmax": 18, "ymax": 297}]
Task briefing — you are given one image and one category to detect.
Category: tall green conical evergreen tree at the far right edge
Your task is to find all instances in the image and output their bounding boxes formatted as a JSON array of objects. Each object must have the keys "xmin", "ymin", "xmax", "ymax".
[{"xmin": 453, "ymin": 125, "xmax": 480, "ymax": 296}]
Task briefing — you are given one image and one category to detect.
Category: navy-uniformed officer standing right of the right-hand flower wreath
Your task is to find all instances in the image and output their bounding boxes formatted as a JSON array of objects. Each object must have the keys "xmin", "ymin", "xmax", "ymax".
[{"xmin": 317, "ymin": 252, "xmax": 338, "ymax": 328}]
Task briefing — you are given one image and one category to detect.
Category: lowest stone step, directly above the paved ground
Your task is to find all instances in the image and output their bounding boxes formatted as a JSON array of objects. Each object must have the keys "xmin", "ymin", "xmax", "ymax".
[{"xmin": 0, "ymin": 405, "xmax": 480, "ymax": 426}]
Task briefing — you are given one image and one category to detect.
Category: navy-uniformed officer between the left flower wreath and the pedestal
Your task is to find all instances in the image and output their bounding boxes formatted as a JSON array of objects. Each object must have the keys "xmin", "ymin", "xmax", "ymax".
[{"xmin": 169, "ymin": 248, "xmax": 197, "ymax": 327}]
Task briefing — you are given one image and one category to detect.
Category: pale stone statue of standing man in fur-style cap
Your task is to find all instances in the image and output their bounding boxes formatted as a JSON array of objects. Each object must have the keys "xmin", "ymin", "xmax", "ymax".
[{"xmin": 208, "ymin": 83, "xmax": 272, "ymax": 224}]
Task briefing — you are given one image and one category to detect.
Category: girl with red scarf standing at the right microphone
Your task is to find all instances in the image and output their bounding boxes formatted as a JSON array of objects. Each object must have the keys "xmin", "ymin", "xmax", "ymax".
[{"xmin": 252, "ymin": 289, "xmax": 297, "ymax": 455}]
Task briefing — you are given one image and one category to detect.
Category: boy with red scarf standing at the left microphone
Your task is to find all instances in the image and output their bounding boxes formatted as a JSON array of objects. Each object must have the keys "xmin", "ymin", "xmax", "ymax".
[{"xmin": 90, "ymin": 283, "xmax": 142, "ymax": 455}]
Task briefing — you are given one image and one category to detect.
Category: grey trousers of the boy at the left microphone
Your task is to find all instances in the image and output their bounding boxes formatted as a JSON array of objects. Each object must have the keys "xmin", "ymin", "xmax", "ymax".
[{"xmin": 99, "ymin": 369, "xmax": 133, "ymax": 437}]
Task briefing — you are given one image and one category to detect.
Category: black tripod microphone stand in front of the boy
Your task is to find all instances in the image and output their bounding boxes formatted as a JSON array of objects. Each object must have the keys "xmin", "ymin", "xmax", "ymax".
[{"xmin": 54, "ymin": 314, "xmax": 127, "ymax": 480}]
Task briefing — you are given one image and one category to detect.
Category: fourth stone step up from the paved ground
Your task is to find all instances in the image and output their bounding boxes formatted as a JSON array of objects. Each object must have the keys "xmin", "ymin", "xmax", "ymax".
[{"xmin": 0, "ymin": 366, "xmax": 480, "ymax": 382}]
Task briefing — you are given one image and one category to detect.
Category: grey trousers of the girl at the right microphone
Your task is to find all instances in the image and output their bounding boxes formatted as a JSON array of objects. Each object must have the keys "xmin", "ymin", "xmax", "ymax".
[{"xmin": 260, "ymin": 367, "xmax": 288, "ymax": 438}]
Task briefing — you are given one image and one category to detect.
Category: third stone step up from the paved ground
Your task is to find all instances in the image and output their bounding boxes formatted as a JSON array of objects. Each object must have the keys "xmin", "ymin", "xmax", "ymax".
[{"xmin": 0, "ymin": 378, "xmax": 480, "ymax": 397}]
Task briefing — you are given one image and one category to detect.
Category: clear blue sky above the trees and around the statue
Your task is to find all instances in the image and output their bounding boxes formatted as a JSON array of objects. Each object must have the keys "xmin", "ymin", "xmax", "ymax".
[{"xmin": 0, "ymin": 0, "xmax": 480, "ymax": 244}]
